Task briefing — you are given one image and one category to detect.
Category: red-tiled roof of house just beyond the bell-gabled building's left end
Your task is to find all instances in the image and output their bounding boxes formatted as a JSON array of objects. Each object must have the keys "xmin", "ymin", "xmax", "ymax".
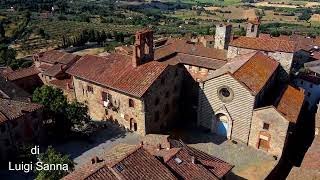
[{"xmin": 39, "ymin": 50, "xmax": 80, "ymax": 64}]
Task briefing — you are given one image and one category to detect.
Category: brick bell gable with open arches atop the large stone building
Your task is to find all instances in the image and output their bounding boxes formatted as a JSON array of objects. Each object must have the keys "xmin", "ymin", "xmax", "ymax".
[{"xmin": 132, "ymin": 30, "xmax": 154, "ymax": 67}]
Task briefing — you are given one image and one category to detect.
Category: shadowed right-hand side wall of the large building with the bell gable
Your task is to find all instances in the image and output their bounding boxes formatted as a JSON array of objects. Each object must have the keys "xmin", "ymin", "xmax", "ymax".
[{"xmin": 143, "ymin": 66, "xmax": 183, "ymax": 134}]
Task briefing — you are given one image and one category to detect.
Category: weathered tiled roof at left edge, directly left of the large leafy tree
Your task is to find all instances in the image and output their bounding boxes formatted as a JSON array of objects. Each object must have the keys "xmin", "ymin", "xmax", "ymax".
[{"xmin": 0, "ymin": 98, "xmax": 42, "ymax": 123}]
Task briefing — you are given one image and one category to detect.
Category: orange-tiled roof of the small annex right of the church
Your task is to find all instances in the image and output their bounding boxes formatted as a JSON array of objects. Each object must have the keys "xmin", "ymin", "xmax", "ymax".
[{"xmin": 277, "ymin": 85, "xmax": 304, "ymax": 123}]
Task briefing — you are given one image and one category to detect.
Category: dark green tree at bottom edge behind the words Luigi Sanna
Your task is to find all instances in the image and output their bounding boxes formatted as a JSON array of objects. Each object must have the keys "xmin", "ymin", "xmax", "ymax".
[{"xmin": 35, "ymin": 146, "xmax": 75, "ymax": 180}]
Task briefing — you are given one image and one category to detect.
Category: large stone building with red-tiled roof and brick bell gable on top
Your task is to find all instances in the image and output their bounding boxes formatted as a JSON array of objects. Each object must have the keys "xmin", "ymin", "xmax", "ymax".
[{"xmin": 67, "ymin": 30, "xmax": 183, "ymax": 135}]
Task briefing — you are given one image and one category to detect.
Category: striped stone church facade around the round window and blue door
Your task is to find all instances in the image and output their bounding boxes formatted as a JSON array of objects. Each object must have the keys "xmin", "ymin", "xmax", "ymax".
[{"xmin": 198, "ymin": 74, "xmax": 255, "ymax": 143}]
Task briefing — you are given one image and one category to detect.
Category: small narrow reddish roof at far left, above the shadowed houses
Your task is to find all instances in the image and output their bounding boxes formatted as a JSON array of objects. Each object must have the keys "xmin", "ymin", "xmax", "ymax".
[{"xmin": 3, "ymin": 66, "xmax": 39, "ymax": 81}]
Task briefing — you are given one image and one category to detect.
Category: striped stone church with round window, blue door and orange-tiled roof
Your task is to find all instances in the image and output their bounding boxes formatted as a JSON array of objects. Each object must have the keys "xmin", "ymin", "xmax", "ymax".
[{"xmin": 198, "ymin": 52, "xmax": 279, "ymax": 143}]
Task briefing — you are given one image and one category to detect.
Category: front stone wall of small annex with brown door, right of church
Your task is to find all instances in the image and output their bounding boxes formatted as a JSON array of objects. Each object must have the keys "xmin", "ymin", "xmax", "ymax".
[{"xmin": 249, "ymin": 106, "xmax": 289, "ymax": 158}]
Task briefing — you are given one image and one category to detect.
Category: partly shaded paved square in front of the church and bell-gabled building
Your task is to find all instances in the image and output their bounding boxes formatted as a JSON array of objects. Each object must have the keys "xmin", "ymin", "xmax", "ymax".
[{"xmin": 55, "ymin": 124, "xmax": 277, "ymax": 179}]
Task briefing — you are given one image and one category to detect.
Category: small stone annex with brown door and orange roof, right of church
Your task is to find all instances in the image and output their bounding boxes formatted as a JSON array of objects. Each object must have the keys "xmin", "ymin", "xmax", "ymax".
[{"xmin": 249, "ymin": 85, "xmax": 304, "ymax": 158}]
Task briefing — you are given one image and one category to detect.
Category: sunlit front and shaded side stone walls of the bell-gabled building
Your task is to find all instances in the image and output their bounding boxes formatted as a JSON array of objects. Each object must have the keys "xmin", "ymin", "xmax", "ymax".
[{"xmin": 73, "ymin": 66, "xmax": 183, "ymax": 135}]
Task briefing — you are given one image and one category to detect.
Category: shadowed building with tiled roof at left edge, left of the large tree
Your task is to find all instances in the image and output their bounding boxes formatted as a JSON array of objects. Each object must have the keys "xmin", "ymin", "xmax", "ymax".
[{"xmin": 0, "ymin": 98, "xmax": 42, "ymax": 159}]
